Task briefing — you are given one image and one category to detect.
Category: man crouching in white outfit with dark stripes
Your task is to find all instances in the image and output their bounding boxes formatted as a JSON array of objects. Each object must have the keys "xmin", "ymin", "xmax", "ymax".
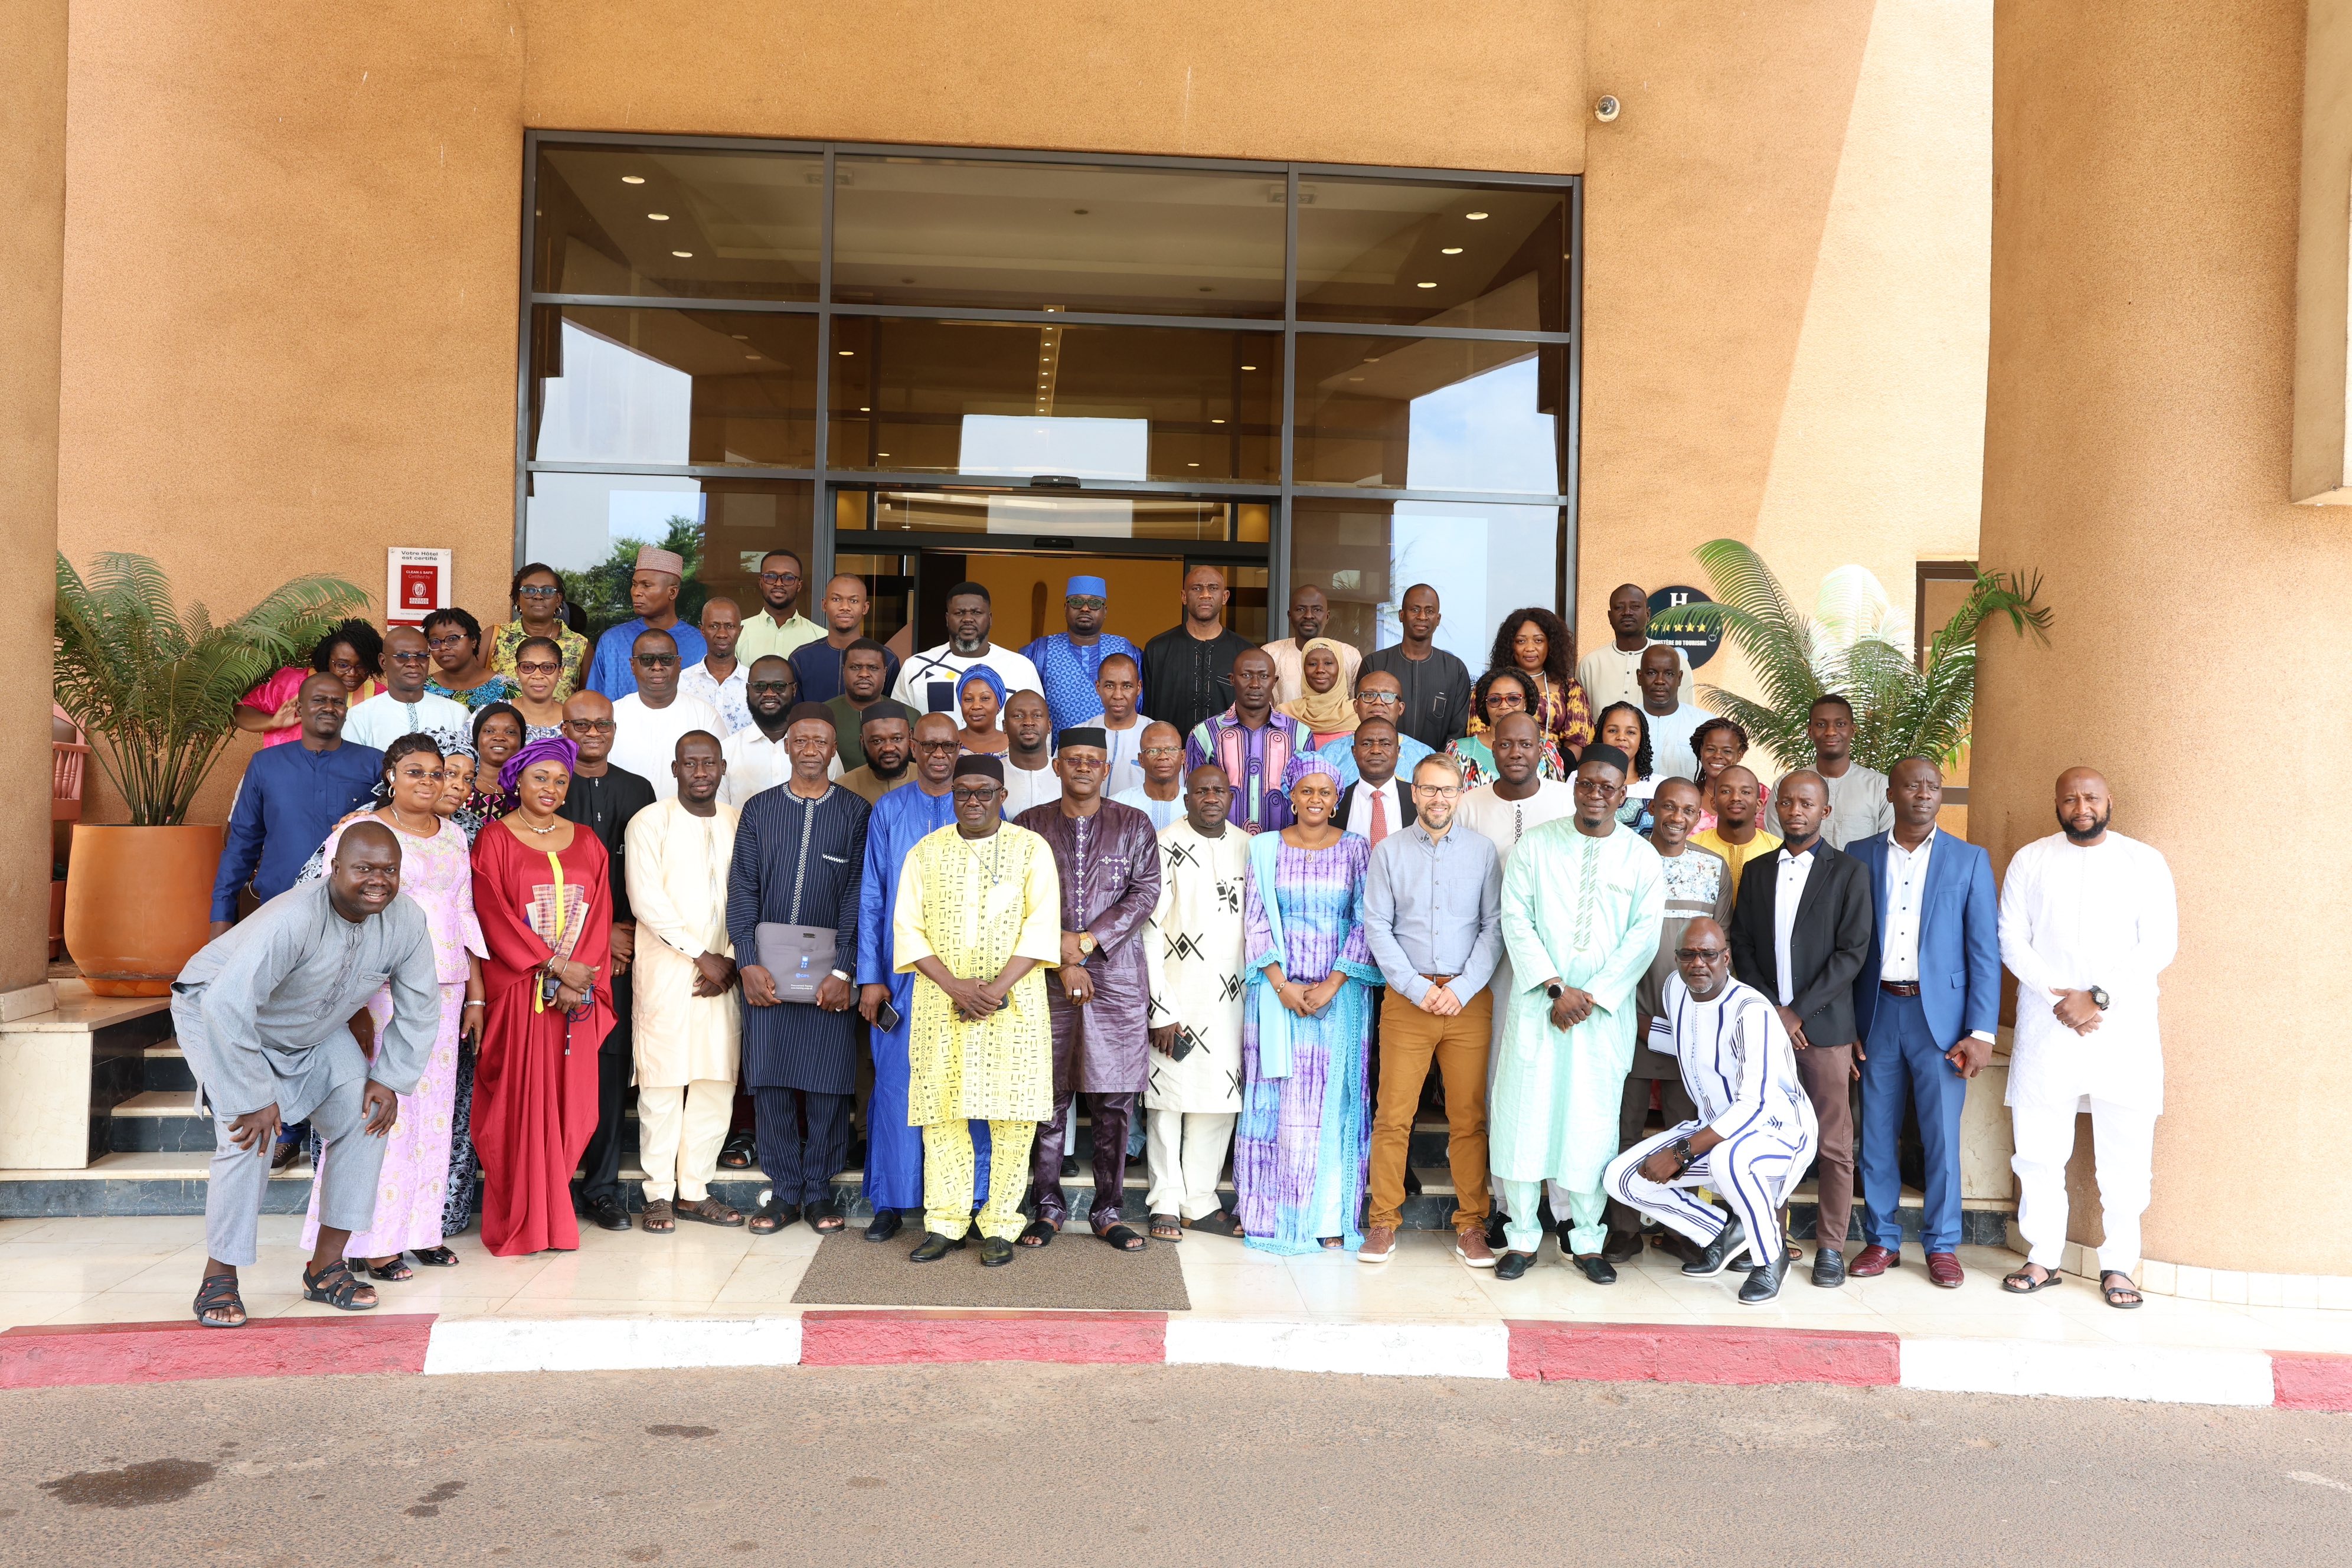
[{"xmin": 1606, "ymin": 917, "xmax": 1821, "ymax": 1307}]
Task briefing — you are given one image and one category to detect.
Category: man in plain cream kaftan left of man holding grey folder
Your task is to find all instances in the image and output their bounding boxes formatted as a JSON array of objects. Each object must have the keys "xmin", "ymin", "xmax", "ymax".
[{"xmin": 626, "ymin": 736, "xmax": 743, "ymax": 1230}]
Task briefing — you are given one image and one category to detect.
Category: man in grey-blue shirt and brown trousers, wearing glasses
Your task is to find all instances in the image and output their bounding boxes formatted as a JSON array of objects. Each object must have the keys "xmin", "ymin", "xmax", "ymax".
[{"xmin": 1357, "ymin": 752, "xmax": 1503, "ymax": 1269}]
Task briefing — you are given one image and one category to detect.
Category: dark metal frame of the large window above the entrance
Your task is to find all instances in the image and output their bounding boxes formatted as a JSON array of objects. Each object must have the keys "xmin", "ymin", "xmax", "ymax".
[{"xmin": 513, "ymin": 127, "xmax": 1585, "ymax": 630}]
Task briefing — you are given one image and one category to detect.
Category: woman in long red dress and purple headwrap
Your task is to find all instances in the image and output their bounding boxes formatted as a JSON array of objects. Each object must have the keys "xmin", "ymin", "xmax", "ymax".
[{"xmin": 473, "ymin": 738, "xmax": 612, "ymax": 1257}]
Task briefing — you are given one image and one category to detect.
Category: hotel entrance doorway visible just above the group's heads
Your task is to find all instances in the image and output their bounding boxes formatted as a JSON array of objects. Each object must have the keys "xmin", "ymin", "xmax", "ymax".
[{"xmin": 832, "ymin": 486, "xmax": 1275, "ymax": 658}]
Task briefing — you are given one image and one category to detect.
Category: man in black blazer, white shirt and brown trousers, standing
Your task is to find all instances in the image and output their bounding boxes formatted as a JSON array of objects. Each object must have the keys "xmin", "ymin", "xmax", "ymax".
[{"xmin": 1731, "ymin": 769, "xmax": 1874, "ymax": 1286}]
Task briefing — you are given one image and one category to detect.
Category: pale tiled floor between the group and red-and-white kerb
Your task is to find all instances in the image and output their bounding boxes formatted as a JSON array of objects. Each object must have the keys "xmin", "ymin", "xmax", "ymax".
[{"xmin": 14, "ymin": 1216, "xmax": 2352, "ymax": 1354}]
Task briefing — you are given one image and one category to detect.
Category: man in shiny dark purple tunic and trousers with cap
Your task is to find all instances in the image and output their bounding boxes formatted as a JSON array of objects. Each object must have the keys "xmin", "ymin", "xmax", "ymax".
[{"xmin": 1016, "ymin": 724, "xmax": 1159, "ymax": 1253}]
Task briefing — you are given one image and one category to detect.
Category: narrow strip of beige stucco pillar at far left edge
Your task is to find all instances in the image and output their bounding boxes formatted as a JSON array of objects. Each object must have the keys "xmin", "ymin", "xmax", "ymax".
[{"xmin": 0, "ymin": 0, "xmax": 66, "ymax": 992}]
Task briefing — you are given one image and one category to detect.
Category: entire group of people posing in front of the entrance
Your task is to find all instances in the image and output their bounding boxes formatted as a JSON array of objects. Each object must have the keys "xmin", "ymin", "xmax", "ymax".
[{"xmin": 174, "ymin": 550, "xmax": 2173, "ymax": 1326}]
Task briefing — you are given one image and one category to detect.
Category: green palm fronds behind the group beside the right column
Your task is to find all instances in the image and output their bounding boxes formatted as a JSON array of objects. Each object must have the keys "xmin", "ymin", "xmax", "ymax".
[{"xmin": 1649, "ymin": 538, "xmax": 2051, "ymax": 773}]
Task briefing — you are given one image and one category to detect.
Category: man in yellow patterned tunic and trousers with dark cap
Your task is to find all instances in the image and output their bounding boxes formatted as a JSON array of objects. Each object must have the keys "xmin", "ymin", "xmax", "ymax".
[{"xmin": 891, "ymin": 752, "xmax": 1061, "ymax": 1267}]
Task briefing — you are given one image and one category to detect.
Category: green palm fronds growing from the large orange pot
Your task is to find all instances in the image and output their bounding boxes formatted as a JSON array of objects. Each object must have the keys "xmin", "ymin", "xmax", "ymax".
[{"xmin": 54, "ymin": 555, "xmax": 367, "ymax": 825}]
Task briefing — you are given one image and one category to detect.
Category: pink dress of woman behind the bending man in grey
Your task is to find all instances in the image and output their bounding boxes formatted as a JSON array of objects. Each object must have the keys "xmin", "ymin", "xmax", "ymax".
[{"xmin": 301, "ymin": 821, "xmax": 487, "ymax": 1257}]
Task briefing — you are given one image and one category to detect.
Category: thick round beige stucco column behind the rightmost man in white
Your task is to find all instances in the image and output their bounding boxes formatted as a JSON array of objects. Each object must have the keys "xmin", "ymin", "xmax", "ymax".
[{"xmin": 1971, "ymin": 0, "xmax": 2352, "ymax": 1274}]
